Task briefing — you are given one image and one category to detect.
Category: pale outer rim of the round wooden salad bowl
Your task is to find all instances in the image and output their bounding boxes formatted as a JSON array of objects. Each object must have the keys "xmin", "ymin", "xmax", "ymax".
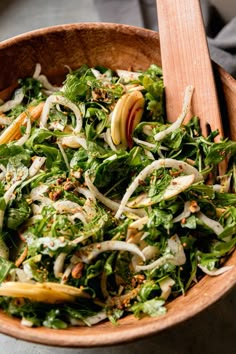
[{"xmin": 0, "ymin": 22, "xmax": 236, "ymax": 348}]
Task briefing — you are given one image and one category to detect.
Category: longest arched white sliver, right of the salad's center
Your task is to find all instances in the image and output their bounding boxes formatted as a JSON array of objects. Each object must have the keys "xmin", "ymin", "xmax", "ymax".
[{"xmin": 115, "ymin": 158, "xmax": 203, "ymax": 219}]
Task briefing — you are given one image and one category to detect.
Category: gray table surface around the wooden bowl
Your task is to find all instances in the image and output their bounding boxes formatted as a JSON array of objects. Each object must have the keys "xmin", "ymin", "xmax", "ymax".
[{"xmin": 0, "ymin": 0, "xmax": 236, "ymax": 354}]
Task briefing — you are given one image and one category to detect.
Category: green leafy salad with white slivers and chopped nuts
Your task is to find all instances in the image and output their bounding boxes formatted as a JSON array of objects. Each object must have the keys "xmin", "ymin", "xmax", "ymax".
[{"xmin": 0, "ymin": 64, "xmax": 236, "ymax": 328}]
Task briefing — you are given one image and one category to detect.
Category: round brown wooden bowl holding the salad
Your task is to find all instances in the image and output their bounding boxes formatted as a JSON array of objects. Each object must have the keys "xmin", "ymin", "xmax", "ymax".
[{"xmin": 0, "ymin": 23, "xmax": 236, "ymax": 347}]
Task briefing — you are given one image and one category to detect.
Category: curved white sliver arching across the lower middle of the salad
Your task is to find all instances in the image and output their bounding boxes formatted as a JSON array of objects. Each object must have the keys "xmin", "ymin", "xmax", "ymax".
[{"xmin": 77, "ymin": 240, "xmax": 145, "ymax": 263}]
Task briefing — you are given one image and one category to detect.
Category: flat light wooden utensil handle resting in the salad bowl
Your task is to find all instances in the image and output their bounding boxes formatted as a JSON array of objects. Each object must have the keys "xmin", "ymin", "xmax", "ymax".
[{"xmin": 157, "ymin": 0, "xmax": 223, "ymax": 135}]
